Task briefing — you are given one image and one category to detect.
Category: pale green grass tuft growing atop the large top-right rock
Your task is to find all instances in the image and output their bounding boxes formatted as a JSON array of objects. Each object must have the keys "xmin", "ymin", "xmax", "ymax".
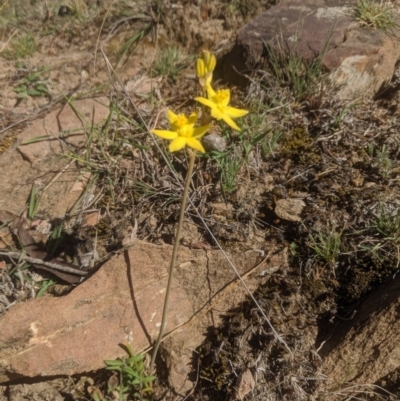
[{"xmin": 354, "ymin": 0, "xmax": 397, "ymax": 32}]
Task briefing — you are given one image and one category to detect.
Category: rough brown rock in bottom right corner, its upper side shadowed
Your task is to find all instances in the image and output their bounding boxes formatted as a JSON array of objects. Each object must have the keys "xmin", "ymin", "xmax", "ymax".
[{"xmin": 320, "ymin": 274, "xmax": 400, "ymax": 390}]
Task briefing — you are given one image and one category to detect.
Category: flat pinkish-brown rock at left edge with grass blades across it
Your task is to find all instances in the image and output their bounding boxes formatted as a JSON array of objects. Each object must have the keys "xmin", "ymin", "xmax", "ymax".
[{"xmin": 0, "ymin": 98, "xmax": 109, "ymax": 218}]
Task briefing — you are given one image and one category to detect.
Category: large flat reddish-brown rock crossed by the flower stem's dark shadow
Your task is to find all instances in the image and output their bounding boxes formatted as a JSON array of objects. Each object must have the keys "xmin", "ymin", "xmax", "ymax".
[{"xmin": 0, "ymin": 243, "xmax": 194, "ymax": 381}]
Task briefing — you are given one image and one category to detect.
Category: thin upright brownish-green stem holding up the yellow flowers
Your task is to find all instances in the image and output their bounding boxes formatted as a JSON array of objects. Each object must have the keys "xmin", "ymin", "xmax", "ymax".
[{"xmin": 150, "ymin": 149, "xmax": 196, "ymax": 372}]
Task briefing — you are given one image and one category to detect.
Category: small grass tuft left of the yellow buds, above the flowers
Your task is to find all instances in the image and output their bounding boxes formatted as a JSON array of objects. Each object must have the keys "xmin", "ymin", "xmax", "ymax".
[{"xmin": 153, "ymin": 46, "xmax": 191, "ymax": 81}]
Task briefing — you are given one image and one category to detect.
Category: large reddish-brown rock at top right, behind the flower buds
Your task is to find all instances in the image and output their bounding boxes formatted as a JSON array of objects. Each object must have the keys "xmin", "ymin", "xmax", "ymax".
[{"xmin": 223, "ymin": 0, "xmax": 400, "ymax": 98}]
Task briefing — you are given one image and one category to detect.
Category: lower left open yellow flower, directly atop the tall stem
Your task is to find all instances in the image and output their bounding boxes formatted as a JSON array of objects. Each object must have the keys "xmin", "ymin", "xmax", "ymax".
[{"xmin": 150, "ymin": 110, "xmax": 211, "ymax": 153}]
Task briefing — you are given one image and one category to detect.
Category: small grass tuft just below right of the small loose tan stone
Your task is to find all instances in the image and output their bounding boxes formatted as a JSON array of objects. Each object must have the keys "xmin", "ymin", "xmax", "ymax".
[{"xmin": 308, "ymin": 226, "xmax": 342, "ymax": 266}]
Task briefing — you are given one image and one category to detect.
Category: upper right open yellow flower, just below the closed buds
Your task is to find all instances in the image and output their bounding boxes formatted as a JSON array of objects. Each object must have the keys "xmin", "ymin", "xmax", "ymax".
[{"xmin": 194, "ymin": 85, "xmax": 248, "ymax": 131}]
